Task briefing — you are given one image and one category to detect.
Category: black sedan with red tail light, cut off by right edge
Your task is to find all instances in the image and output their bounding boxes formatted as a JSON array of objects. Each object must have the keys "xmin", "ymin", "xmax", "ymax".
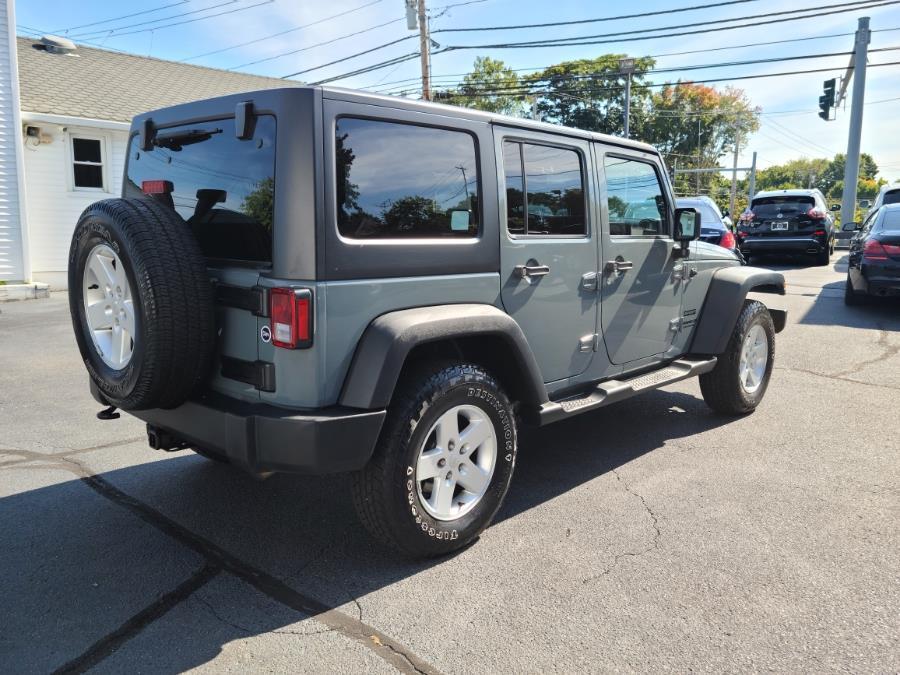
[{"xmin": 841, "ymin": 204, "xmax": 900, "ymax": 305}]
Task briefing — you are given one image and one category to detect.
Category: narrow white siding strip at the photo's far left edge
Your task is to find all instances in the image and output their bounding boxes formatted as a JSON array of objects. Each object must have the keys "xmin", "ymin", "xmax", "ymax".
[{"xmin": 0, "ymin": 0, "xmax": 25, "ymax": 282}]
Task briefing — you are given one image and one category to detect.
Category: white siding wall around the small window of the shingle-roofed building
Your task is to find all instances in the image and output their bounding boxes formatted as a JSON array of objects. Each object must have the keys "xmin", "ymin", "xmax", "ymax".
[{"xmin": 25, "ymin": 124, "xmax": 128, "ymax": 280}]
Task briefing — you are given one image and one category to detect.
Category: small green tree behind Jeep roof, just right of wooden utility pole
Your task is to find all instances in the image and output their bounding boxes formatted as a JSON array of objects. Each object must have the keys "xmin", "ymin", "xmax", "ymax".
[{"xmin": 435, "ymin": 56, "xmax": 525, "ymax": 115}]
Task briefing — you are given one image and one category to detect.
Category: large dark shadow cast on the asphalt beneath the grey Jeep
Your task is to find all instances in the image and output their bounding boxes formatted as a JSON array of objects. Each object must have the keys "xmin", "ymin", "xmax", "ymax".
[{"xmin": 0, "ymin": 392, "xmax": 729, "ymax": 672}]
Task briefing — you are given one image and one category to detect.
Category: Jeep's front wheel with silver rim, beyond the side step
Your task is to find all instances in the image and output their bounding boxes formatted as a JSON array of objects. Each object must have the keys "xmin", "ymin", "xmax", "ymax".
[{"xmin": 700, "ymin": 301, "xmax": 775, "ymax": 415}]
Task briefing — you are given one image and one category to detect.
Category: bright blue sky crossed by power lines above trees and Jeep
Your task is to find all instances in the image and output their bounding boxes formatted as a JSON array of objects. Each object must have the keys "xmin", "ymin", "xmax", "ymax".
[{"xmin": 16, "ymin": 0, "xmax": 900, "ymax": 181}]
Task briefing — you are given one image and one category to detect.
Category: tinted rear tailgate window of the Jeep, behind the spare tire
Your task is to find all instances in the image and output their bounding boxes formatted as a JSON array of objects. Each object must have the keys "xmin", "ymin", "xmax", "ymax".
[{"xmin": 125, "ymin": 115, "xmax": 275, "ymax": 263}]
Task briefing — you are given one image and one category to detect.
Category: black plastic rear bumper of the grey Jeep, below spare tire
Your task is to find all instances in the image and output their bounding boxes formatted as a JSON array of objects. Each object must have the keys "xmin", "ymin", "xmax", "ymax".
[{"xmin": 91, "ymin": 386, "xmax": 385, "ymax": 474}]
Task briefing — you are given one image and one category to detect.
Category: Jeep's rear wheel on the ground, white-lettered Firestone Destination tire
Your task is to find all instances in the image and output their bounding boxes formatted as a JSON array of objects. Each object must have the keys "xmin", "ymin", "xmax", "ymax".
[{"xmin": 352, "ymin": 363, "xmax": 517, "ymax": 557}]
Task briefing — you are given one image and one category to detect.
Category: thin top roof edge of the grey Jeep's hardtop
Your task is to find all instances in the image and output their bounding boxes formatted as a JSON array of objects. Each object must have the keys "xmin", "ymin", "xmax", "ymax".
[{"xmin": 132, "ymin": 86, "xmax": 659, "ymax": 155}]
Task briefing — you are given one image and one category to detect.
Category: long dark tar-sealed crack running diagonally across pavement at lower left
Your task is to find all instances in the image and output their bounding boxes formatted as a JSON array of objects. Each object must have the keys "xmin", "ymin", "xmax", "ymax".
[{"xmin": 10, "ymin": 450, "xmax": 440, "ymax": 675}]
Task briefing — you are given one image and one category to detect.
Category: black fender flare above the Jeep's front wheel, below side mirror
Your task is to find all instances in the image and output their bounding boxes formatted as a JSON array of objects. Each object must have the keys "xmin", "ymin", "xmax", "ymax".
[{"xmin": 689, "ymin": 266, "xmax": 787, "ymax": 355}]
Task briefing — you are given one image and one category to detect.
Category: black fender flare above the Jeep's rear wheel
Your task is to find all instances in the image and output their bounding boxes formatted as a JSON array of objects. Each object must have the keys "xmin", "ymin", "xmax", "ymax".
[{"xmin": 340, "ymin": 304, "xmax": 548, "ymax": 410}]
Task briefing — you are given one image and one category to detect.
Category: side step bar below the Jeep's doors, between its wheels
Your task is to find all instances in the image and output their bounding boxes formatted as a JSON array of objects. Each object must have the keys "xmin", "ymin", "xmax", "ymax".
[{"xmin": 539, "ymin": 356, "xmax": 716, "ymax": 426}]
